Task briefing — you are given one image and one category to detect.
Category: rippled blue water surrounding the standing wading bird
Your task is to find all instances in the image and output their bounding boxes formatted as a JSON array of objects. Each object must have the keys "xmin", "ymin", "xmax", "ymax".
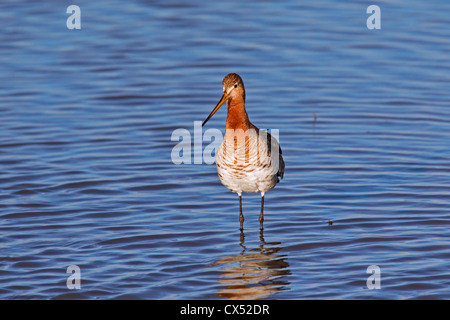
[{"xmin": 0, "ymin": 0, "xmax": 450, "ymax": 299}]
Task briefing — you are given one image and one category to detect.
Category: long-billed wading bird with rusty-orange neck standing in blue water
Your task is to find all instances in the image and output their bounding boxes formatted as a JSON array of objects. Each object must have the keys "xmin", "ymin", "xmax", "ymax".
[{"xmin": 202, "ymin": 73, "xmax": 284, "ymax": 230}]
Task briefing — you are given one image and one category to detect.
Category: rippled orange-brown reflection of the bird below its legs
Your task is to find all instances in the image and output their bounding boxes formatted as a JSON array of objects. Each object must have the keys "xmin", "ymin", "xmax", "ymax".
[{"xmin": 208, "ymin": 230, "xmax": 290, "ymax": 300}]
